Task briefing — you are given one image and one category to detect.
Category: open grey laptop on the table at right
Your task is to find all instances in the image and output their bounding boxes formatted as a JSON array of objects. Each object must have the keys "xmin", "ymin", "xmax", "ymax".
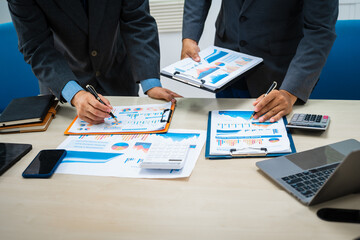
[{"xmin": 256, "ymin": 139, "xmax": 360, "ymax": 206}]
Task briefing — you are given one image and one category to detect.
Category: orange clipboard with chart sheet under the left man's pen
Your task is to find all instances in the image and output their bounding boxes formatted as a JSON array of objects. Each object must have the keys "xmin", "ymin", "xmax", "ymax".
[{"xmin": 64, "ymin": 102, "xmax": 175, "ymax": 135}]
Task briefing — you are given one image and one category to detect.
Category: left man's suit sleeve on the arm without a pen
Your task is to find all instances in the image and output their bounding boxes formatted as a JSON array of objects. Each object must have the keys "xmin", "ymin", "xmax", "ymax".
[{"xmin": 120, "ymin": 0, "xmax": 160, "ymax": 82}]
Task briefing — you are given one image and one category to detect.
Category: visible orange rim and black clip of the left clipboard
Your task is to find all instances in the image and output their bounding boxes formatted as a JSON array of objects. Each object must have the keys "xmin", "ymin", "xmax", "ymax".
[{"xmin": 64, "ymin": 102, "xmax": 176, "ymax": 135}]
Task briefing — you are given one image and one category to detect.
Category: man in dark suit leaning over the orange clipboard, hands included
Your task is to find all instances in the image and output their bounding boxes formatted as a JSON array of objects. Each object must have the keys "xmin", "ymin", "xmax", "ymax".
[{"xmin": 8, "ymin": 0, "xmax": 179, "ymax": 123}]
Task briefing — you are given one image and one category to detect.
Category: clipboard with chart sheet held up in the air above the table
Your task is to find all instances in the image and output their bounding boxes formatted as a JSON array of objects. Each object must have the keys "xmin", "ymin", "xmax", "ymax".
[{"xmin": 160, "ymin": 46, "xmax": 263, "ymax": 92}]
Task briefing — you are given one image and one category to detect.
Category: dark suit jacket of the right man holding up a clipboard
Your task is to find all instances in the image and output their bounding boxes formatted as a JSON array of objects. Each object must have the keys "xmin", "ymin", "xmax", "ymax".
[{"xmin": 183, "ymin": 0, "xmax": 339, "ymax": 102}]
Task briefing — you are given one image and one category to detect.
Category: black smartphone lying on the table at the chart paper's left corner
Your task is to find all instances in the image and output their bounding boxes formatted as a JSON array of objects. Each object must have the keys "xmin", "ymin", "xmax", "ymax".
[{"xmin": 22, "ymin": 149, "xmax": 66, "ymax": 178}]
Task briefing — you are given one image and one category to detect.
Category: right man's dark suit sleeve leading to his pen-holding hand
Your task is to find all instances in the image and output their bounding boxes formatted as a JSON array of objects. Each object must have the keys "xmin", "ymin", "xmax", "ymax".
[{"xmin": 281, "ymin": 0, "xmax": 339, "ymax": 102}]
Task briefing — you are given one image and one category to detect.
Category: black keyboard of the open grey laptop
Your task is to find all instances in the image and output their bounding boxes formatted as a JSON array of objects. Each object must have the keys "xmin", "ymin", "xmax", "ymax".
[{"xmin": 281, "ymin": 163, "xmax": 340, "ymax": 197}]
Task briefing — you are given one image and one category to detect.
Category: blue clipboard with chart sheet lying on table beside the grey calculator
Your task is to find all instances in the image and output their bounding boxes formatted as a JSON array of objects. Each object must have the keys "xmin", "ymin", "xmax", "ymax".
[{"xmin": 205, "ymin": 110, "xmax": 296, "ymax": 159}]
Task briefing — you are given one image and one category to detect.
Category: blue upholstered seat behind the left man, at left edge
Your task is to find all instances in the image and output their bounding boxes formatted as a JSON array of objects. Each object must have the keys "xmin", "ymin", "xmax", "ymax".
[{"xmin": 0, "ymin": 22, "xmax": 40, "ymax": 113}]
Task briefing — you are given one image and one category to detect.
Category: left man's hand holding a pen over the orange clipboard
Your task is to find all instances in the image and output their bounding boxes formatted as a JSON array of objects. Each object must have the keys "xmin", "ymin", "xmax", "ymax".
[{"xmin": 71, "ymin": 90, "xmax": 112, "ymax": 124}]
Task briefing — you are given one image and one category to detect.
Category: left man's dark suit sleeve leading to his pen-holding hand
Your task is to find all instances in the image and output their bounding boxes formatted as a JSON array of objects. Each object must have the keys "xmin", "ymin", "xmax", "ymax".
[{"xmin": 8, "ymin": 0, "xmax": 76, "ymax": 99}]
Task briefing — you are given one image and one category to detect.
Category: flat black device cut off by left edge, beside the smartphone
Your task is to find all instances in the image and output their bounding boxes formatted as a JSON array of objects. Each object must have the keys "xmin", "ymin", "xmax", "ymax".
[{"xmin": 0, "ymin": 143, "xmax": 32, "ymax": 175}]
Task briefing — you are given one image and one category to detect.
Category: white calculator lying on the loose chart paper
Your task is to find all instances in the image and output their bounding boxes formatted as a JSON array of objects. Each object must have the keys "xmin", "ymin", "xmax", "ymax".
[{"xmin": 140, "ymin": 143, "xmax": 190, "ymax": 169}]
